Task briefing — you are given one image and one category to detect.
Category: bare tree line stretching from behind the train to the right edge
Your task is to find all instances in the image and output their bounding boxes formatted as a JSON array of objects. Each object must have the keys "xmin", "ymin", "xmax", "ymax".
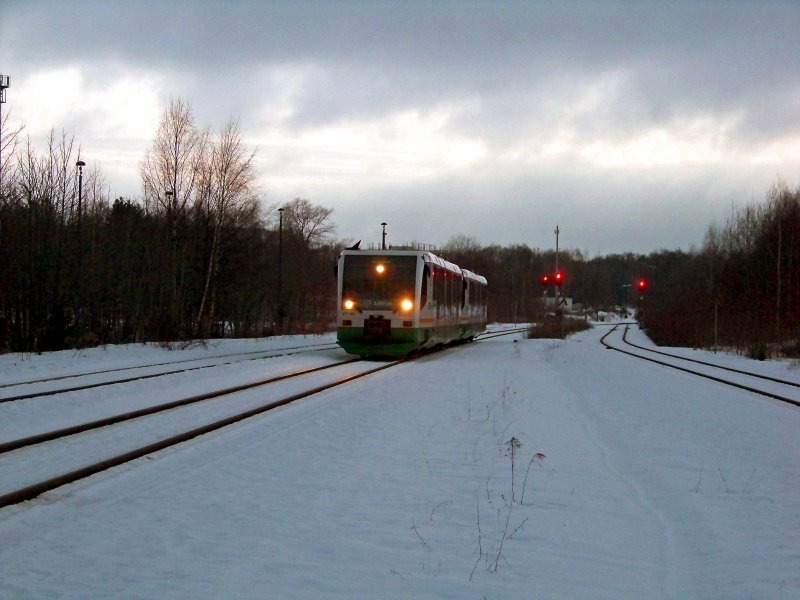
[{"xmin": 444, "ymin": 182, "xmax": 800, "ymax": 358}]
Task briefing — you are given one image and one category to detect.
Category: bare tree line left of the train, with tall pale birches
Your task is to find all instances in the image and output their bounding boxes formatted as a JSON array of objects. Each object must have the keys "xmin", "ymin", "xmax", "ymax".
[{"xmin": 0, "ymin": 100, "xmax": 340, "ymax": 352}]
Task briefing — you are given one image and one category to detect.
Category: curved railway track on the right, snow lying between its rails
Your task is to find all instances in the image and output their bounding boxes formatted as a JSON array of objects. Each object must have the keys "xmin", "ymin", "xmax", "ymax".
[{"xmin": 600, "ymin": 324, "xmax": 800, "ymax": 406}]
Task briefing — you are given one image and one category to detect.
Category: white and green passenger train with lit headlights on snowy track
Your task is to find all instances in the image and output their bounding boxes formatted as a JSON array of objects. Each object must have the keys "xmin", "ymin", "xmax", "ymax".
[{"xmin": 336, "ymin": 249, "xmax": 487, "ymax": 357}]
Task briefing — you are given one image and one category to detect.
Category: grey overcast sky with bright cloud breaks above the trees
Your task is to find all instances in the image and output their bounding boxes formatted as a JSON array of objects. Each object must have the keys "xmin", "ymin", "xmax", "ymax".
[{"xmin": 0, "ymin": 0, "xmax": 800, "ymax": 256}]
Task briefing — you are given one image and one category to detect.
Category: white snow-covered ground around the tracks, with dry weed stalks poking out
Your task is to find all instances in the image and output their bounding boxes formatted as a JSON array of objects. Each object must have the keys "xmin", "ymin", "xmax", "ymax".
[{"xmin": 0, "ymin": 327, "xmax": 800, "ymax": 600}]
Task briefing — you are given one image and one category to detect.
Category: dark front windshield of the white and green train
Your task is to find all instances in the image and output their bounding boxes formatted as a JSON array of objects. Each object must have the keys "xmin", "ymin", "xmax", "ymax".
[{"xmin": 342, "ymin": 255, "xmax": 417, "ymax": 310}]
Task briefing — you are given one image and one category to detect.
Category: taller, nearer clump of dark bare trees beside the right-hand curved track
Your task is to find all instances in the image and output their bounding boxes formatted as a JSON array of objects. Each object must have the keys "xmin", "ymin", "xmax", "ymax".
[{"xmin": 645, "ymin": 182, "xmax": 800, "ymax": 358}]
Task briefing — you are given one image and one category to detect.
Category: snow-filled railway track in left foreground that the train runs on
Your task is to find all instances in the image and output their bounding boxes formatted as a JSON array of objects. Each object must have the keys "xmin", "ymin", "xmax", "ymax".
[{"xmin": 0, "ymin": 328, "xmax": 525, "ymax": 508}]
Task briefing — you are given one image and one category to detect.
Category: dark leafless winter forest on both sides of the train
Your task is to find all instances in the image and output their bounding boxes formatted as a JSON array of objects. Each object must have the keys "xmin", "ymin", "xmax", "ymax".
[{"xmin": 0, "ymin": 100, "xmax": 800, "ymax": 358}]
